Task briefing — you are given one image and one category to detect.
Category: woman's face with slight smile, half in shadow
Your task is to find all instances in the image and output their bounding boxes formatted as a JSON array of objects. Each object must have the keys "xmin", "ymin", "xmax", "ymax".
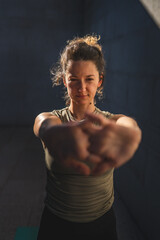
[{"xmin": 63, "ymin": 60, "xmax": 102, "ymax": 104}]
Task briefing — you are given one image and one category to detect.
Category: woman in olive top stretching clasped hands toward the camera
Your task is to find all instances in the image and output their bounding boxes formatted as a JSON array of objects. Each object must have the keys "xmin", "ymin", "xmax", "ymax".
[{"xmin": 34, "ymin": 35, "xmax": 141, "ymax": 240}]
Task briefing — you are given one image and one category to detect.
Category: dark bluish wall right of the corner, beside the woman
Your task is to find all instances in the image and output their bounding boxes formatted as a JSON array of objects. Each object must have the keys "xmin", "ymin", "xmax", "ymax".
[{"xmin": 85, "ymin": 0, "xmax": 160, "ymax": 240}]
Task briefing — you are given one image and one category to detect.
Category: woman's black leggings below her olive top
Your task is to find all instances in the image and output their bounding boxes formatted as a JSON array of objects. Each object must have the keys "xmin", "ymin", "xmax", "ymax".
[{"xmin": 37, "ymin": 207, "xmax": 118, "ymax": 240}]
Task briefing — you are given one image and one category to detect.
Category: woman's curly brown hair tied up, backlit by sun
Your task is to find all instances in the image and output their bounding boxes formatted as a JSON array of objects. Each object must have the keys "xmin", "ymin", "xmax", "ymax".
[{"xmin": 50, "ymin": 34, "xmax": 105, "ymax": 105}]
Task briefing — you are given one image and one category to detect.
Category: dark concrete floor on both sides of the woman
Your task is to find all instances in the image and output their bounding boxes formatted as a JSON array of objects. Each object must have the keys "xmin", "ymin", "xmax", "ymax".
[{"xmin": 0, "ymin": 126, "xmax": 144, "ymax": 240}]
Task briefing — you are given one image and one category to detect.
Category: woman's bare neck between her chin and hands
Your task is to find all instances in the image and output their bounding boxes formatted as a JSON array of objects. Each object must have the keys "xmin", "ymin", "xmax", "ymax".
[{"xmin": 69, "ymin": 103, "xmax": 95, "ymax": 120}]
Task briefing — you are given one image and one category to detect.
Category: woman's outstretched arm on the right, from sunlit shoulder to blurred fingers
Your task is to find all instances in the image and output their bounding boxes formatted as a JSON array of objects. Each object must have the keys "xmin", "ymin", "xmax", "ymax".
[{"xmin": 84, "ymin": 114, "xmax": 142, "ymax": 174}]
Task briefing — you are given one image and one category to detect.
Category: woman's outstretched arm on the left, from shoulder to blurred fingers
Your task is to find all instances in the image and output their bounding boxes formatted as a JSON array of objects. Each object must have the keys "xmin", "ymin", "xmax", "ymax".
[{"xmin": 33, "ymin": 113, "xmax": 100, "ymax": 175}]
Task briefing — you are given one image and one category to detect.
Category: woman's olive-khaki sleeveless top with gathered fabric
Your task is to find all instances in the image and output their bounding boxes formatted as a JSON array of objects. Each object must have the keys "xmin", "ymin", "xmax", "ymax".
[{"xmin": 44, "ymin": 107, "xmax": 114, "ymax": 223}]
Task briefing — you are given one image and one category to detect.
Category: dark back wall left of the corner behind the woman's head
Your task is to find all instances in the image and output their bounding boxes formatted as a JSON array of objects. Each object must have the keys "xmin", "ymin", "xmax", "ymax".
[{"xmin": 0, "ymin": 0, "xmax": 83, "ymax": 125}]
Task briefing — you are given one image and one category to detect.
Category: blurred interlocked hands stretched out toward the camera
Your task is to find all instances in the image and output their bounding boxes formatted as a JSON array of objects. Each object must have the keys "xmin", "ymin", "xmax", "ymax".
[{"xmin": 45, "ymin": 114, "xmax": 140, "ymax": 175}]
